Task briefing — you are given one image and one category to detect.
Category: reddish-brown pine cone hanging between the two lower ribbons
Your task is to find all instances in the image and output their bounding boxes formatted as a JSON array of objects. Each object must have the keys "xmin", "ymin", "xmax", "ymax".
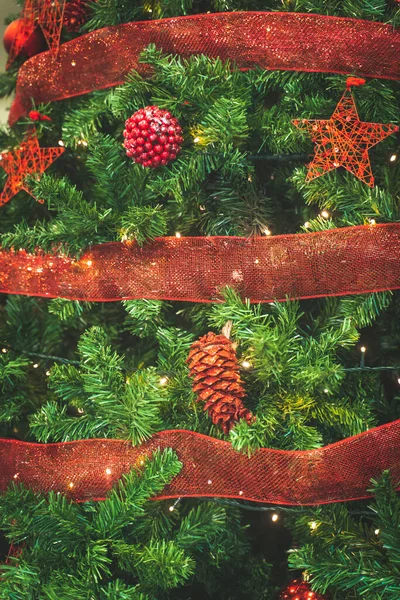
[{"xmin": 186, "ymin": 332, "xmax": 255, "ymax": 435}]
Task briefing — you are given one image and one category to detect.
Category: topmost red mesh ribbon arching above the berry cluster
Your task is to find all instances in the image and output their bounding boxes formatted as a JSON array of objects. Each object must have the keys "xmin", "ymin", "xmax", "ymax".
[{"xmin": 9, "ymin": 12, "xmax": 400, "ymax": 125}]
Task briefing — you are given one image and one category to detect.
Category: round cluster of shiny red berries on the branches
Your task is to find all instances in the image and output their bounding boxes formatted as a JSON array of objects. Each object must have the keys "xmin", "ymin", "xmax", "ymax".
[{"xmin": 124, "ymin": 106, "xmax": 183, "ymax": 168}]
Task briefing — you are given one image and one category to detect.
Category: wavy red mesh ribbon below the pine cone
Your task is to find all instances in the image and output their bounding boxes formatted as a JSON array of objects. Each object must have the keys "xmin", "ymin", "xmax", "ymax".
[{"xmin": 0, "ymin": 420, "xmax": 400, "ymax": 505}]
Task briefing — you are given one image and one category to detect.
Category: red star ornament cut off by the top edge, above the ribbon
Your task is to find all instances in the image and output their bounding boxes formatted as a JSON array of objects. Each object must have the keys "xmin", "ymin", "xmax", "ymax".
[{"xmin": 7, "ymin": 0, "xmax": 65, "ymax": 68}]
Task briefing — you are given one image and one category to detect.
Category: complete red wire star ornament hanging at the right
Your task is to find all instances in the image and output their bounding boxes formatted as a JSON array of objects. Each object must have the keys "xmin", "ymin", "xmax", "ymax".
[{"xmin": 292, "ymin": 77, "xmax": 399, "ymax": 187}]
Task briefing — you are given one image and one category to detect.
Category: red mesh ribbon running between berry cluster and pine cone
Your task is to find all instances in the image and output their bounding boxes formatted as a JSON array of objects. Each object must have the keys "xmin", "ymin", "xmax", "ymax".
[{"xmin": 0, "ymin": 223, "xmax": 400, "ymax": 302}]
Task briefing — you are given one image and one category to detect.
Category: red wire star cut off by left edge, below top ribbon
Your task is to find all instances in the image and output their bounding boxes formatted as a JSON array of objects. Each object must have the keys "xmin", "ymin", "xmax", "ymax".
[{"xmin": 0, "ymin": 134, "xmax": 65, "ymax": 206}]
